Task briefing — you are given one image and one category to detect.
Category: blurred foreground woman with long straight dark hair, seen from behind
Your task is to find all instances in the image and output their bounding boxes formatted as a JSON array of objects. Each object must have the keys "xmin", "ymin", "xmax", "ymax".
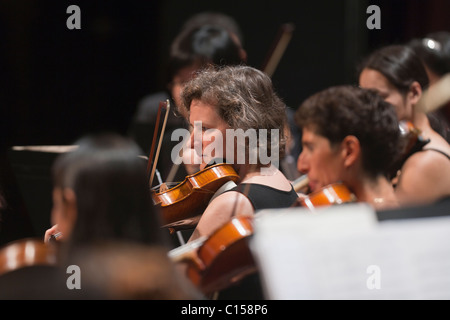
[{"xmin": 45, "ymin": 134, "xmax": 202, "ymax": 299}]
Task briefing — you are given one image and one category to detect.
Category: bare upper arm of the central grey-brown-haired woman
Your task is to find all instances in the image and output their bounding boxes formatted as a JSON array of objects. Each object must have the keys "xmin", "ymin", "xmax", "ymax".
[{"xmin": 189, "ymin": 191, "xmax": 254, "ymax": 241}]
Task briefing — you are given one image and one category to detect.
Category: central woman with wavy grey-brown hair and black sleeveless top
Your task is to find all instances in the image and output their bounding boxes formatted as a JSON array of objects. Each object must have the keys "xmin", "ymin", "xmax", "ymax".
[{"xmin": 181, "ymin": 66, "xmax": 297, "ymax": 240}]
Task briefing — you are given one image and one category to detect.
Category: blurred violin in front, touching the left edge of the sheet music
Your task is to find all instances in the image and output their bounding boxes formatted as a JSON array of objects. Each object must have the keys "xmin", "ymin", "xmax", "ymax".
[{"xmin": 169, "ymin": 217, "xmax": 256, "ymax": 294}]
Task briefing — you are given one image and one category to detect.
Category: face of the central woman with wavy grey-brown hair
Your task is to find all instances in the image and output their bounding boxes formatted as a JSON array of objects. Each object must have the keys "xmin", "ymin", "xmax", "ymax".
[{"xmin": 189, "ymin": 100, "xmax": 230, "ymax": 169}]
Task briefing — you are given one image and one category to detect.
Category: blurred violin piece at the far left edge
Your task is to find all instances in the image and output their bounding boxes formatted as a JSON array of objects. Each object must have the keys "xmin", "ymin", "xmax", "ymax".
[{"xmin": 0, "ymin": 238, "xmax": 57, "ymax": 275}]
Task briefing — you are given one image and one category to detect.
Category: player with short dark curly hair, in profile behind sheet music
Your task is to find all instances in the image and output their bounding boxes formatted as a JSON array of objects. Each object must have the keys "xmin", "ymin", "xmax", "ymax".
[{"xmin": 296, "ymin": 86, "xmax": 400, "ymax": 209}]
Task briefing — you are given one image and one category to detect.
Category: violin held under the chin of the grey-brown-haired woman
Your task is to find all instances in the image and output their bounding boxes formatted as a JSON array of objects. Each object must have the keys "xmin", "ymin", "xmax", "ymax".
[{"xmin": 152, "ymin": 163, "xmax": 239, "ymax": 228}]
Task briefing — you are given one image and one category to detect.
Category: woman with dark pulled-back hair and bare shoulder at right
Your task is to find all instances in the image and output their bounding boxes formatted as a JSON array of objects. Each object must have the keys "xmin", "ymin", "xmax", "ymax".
[{"xmin": 359, "ymin": 45, "xmax": 450, "ymax": 205}]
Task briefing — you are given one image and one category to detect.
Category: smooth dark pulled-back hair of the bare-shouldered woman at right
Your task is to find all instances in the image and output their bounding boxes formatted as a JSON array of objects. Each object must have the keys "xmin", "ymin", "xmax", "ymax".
[{"xmin": 358, "ymin": 45, "xmax": 429, "ymax": 94}]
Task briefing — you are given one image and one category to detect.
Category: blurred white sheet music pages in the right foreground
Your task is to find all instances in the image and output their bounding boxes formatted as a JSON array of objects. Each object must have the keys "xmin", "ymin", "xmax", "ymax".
[{"xmin": 251, "ymin": 203, "xmax": 450, "ymax": 300}]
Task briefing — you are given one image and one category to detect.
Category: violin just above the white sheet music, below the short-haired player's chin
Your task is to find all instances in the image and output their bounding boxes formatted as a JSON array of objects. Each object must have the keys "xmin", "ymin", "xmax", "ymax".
[{"xmin": 295, "ymin": 182, "xmax": 357, "ymax": 210}]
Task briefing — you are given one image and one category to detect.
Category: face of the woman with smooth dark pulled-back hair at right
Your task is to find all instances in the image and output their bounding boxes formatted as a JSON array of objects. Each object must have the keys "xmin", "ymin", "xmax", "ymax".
[{"xmin": 359, "ymin": 68, "xmax": 413, "ymax": 120}]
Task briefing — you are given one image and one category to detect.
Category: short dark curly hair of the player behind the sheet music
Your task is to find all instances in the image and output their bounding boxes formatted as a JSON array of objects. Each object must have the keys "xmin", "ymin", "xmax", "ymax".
[{"xmin": 296, "ymin": 86, "xmax": 401, "ymax": 177}]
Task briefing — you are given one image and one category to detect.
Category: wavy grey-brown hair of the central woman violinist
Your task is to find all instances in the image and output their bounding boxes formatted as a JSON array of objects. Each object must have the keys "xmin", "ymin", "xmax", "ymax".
[{"xmin": 179, "ymin": 65, "xmax": 287, "ymax": 164}]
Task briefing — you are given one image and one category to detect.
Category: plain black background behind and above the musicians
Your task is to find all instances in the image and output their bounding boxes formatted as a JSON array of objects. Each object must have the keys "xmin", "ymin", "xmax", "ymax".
[{"xmin": 0, "ymin": 0, "xmax": 450, "ymax": 242}]
